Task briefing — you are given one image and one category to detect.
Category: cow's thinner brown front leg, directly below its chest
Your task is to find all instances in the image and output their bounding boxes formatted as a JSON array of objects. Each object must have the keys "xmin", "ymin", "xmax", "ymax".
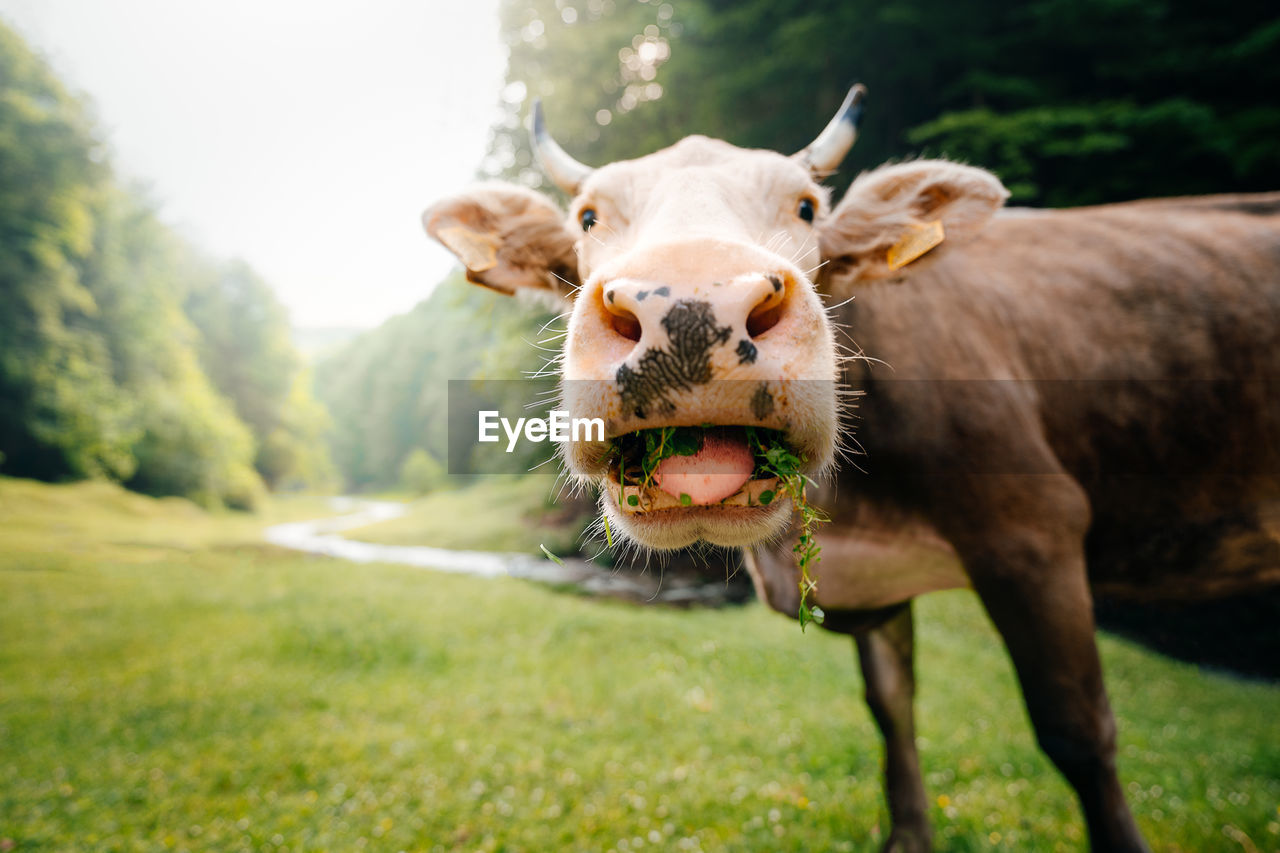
[{"xmin": 854, "ymin": 596, "xmax": 932, "ymax": 853}]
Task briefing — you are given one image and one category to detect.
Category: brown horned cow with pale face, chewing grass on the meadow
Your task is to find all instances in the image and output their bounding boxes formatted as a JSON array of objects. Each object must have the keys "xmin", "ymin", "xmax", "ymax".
[{"xmin": 424, "ymin": 86, "xmax": 1280, "ymax": 852}]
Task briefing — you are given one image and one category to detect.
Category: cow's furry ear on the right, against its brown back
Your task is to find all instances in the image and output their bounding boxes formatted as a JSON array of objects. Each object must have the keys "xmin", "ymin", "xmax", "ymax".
[{"xmin": 818, "ymin": 160, "xmax": 1009, "ymax": 292}]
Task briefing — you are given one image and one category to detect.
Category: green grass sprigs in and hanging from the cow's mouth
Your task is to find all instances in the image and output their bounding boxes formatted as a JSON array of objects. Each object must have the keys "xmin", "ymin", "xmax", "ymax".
[{"xmin": 609, "ymin": 427, "xmax": 828, "ymax": 630}]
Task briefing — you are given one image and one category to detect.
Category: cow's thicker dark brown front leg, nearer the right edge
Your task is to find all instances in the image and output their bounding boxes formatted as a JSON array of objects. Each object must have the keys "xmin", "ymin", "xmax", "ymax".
[{"xmin": 968, "ymin": 530, "xmax": 1147, "ymax": 853}]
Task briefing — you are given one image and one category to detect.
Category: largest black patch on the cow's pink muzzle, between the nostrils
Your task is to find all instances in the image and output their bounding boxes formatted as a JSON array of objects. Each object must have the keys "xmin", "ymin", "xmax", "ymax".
[{"xmin": 617, "ymin": 300, "xmax": 737, "ymax": 419}]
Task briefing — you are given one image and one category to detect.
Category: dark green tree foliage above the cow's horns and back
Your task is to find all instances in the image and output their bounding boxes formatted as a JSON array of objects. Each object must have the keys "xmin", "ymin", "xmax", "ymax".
[{"xmin": 488, "ymin": 0, "xmax": 1280, "ymax": 205}]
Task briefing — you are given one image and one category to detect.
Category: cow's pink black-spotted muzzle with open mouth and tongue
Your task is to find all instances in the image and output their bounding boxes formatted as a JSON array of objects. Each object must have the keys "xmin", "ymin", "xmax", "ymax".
[{"xmin": 563, "ymin": 235, "xmax": 837, "ymax": 548}]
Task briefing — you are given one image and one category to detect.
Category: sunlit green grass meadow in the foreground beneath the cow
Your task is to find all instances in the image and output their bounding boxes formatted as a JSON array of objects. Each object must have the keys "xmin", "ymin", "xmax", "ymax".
[{"xmin": 0, "ymin": 480, "xmax": 1280, "ymax": 853}]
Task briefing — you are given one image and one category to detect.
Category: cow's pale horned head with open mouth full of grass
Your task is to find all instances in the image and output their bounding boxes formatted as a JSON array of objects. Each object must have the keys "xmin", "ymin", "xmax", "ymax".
[{"xmin": 422, "ymin": 86, "xmax": 998, "ymax": 549}]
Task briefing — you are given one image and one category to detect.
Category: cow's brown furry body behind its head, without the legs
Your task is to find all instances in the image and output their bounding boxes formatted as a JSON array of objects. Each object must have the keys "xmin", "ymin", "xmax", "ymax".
[{"xmin": 755, "ymin": 193, "xmax": 1280, "ymax": 613}]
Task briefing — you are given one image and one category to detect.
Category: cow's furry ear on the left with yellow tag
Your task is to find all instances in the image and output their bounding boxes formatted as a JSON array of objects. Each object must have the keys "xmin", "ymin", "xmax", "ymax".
[{"xmin": 422, "ymin": 183, "xmax": 579, "ymax": 297}]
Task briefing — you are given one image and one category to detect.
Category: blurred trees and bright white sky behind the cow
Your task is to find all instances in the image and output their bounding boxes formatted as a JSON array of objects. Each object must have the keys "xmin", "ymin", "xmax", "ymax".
[{"xmin": 0, "ymin": 0, "xmax": 1280, "ymax": 507}]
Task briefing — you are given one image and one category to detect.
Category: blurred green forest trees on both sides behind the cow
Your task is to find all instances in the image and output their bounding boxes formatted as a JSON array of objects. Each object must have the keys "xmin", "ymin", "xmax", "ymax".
[{"xmin": 0, "ymin": 0, "xmax": 1280, "ymax": 499}]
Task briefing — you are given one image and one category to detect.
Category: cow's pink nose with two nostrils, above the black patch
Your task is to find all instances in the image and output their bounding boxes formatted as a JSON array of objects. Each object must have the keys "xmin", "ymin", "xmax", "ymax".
[{"xmin": 603, "ymin": 273, "xmax": 790, "ymax": 342}]
